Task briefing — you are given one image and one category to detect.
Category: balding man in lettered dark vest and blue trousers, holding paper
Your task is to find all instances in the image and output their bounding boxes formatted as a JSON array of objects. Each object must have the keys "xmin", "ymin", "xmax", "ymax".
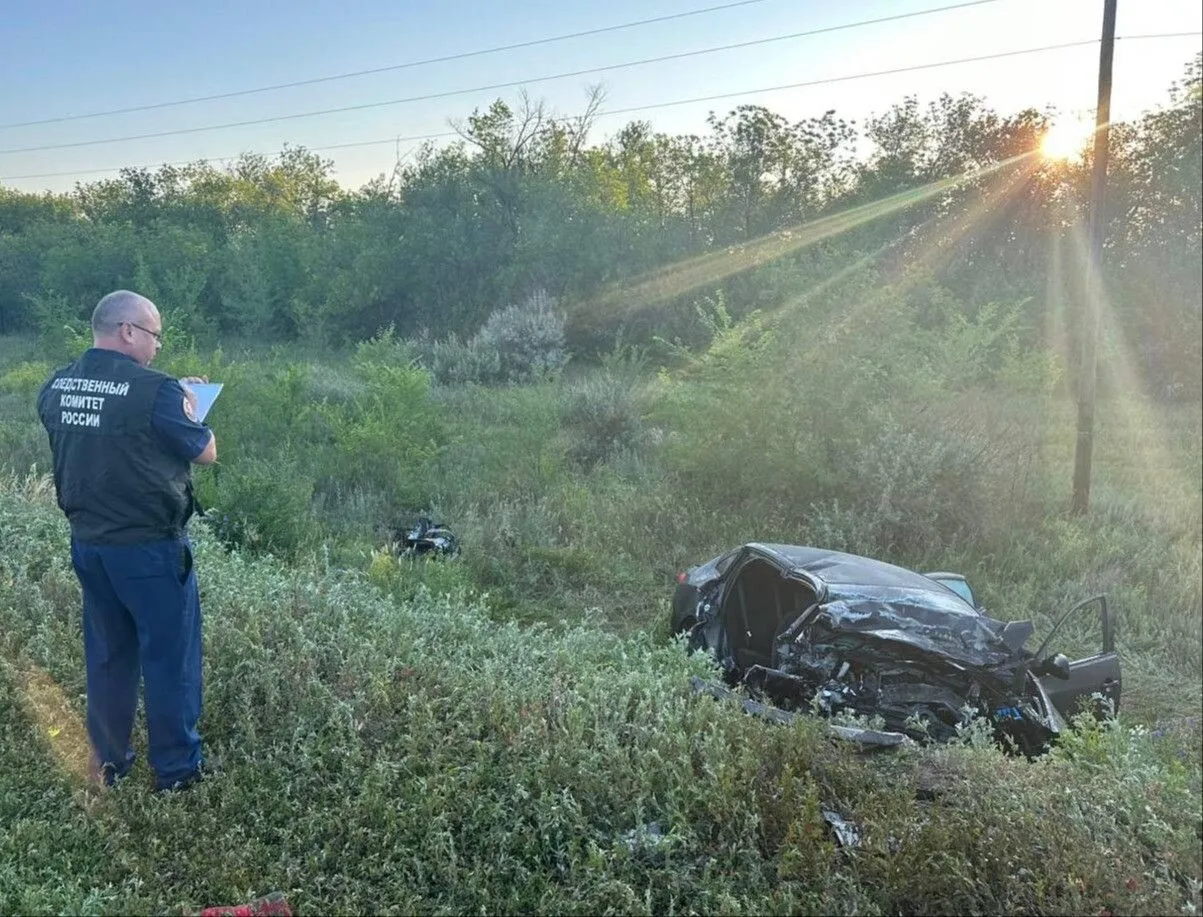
[{"xmin": 37, "ymin": 290, "xmax": 217, "ymax": 791}]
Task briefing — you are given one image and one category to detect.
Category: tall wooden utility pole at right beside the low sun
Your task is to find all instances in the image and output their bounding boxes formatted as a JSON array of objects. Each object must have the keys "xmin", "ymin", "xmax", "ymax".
[{"xmin": 1073, "ymin": 0, "xmax": 1119, "ymax": 514}]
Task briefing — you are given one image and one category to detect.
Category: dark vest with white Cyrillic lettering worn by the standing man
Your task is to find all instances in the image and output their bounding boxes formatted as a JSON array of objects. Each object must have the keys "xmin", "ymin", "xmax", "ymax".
[{"xmin": 37, "ymin": 348, "xmax": 192, "ymax": 545}]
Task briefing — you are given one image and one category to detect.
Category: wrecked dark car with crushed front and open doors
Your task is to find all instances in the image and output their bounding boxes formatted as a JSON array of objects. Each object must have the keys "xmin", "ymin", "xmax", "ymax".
[{"xmin": 671, "ymin": 543, "xmax": 1121, "ymax": 755}]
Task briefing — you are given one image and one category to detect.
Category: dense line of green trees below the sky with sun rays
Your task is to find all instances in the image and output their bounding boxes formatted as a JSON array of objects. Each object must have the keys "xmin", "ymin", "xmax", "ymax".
[{"xmin": 0, "ymin": 58, "xmax": 1203, "ymax": 394}]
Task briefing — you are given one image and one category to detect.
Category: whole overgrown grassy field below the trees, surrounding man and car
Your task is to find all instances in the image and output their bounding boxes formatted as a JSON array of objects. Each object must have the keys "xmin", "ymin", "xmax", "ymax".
[{"xmin": 0, "ymin": 324, "xmax": 1203, "ymax": 913}]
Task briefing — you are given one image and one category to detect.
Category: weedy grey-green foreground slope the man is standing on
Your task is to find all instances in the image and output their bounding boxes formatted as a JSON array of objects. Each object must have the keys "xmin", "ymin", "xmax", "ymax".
[{"xmin": 0, "ymin": 479, "xmax": 1203, "ymax": 913}]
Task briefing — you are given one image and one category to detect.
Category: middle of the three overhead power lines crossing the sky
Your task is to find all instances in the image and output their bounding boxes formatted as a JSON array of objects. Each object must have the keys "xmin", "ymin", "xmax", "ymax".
[{"xmin": 0, "ymin": 0, "xmax": 1015, "ymax": 155}]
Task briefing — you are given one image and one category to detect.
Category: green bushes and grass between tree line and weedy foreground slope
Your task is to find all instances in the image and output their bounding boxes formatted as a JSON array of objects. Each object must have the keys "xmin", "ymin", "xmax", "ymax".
[{"xmin": 0, "ymin": 310, "xmax": 1203, "ymax": 702}]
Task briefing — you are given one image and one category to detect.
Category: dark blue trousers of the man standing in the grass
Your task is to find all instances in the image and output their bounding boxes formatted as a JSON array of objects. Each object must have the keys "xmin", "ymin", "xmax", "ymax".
[{"xmin": 71, "ymin": 538, "xmax": 201, "ymax": 788}]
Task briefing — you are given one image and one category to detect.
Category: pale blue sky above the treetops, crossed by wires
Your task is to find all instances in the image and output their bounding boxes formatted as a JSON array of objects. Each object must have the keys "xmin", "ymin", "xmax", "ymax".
[{"xmin": 0, "ymin": 0, "xmax": 1203, "ymax": 193}]
